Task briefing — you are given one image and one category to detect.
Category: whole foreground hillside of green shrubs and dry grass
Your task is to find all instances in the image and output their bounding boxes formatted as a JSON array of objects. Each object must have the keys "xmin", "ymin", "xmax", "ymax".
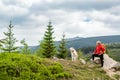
[{"xmin": 0, "ymin": 53, "xmax": 115, "ymax": 80}]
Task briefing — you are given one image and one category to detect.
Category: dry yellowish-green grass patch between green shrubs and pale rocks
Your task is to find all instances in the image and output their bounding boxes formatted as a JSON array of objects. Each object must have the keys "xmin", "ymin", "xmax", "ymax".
[{"xmin": 55, "ymin": 60, "xmax": 111, "ymax": 80}]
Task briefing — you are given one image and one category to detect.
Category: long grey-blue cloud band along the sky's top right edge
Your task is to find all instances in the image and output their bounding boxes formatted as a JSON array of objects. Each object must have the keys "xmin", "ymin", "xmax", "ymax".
[{"xmin": 31, "ymin": 0, "xmax": 120, "ymax": 11}]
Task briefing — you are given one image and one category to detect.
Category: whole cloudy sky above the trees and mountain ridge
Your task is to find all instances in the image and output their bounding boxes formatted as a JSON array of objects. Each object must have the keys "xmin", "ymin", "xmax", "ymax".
[{"xmin": 0, "ymin": 0, "xmax": 120, "ymax": 46}]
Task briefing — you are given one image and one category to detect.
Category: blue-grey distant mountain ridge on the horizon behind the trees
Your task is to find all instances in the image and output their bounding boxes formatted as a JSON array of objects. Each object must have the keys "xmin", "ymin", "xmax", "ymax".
[{"xmin": 30, "ymin": 35, "xmax": 120, "ymax": 52}]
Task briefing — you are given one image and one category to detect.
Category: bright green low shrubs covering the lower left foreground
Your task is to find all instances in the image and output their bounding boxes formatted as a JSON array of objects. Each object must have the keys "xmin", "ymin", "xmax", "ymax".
[{"xmin": 0, "ymin": 53, "xmax": 70, "ymax": 80}]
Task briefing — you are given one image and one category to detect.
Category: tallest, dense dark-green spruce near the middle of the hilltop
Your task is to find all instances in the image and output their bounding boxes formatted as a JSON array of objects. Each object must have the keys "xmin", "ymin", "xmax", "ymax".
[{"xmin": 40, "ymin": 22, "xmax": 56, "ymax": 58}]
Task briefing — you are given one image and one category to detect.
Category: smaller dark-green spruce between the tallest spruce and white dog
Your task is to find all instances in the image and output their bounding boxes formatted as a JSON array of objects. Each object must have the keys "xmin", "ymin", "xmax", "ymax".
[{"xmin": 57, "ymin": 34, "xmax": 68, "ymax": 59}]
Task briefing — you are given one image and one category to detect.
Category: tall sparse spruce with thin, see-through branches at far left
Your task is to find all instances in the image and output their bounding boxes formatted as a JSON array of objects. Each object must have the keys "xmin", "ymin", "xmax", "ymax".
[{"xmin": 1, "ymin": 21, "xmax": 18, "ymax": 53}]
